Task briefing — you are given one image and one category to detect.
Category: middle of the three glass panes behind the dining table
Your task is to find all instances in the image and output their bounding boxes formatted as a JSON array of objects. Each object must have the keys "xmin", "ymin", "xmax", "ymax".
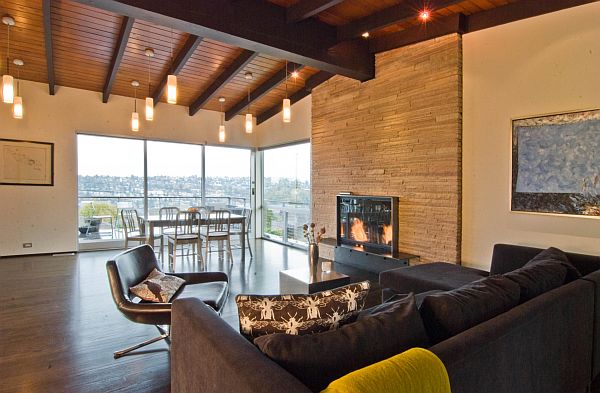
[{"xmin": 147, "ymin": 141, "xmax": 202, "ymax": 216}]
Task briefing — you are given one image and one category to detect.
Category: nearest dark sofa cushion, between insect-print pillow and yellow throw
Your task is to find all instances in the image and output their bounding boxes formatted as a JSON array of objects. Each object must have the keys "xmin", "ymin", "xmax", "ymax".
[{"xmin": 254, "ymin": 295, "xmax": 428, "ymax": 392}]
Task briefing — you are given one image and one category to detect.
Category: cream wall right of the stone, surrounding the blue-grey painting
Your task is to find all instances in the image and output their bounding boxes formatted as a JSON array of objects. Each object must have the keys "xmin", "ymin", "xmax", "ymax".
[{"xmin": 462, "ymin": 3, "xmax": 600, "ymax": 269}]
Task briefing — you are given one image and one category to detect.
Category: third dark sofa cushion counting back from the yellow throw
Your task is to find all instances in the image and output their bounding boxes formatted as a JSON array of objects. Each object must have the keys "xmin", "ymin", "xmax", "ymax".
[{"xmin": 504, "ymin": 260, "xmax": 567, "ymax": 303}]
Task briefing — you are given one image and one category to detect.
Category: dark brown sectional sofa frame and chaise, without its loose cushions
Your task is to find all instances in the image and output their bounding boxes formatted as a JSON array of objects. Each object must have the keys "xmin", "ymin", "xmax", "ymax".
[{"xmin": 171, "ymin": 244, "xmax": 600, "ymax": 393}]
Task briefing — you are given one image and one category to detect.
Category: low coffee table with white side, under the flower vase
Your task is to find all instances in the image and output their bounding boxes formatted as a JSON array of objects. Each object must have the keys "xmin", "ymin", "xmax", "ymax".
[{"xmin": 279, "ymin": 263, "xmax": 350, "ymax": 294}]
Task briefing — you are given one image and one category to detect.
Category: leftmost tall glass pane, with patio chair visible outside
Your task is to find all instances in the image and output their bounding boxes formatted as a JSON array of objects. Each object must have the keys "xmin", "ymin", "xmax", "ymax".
[{"xmin": 77, "ymin": 135, "xmax": 144, "ymax": 243}]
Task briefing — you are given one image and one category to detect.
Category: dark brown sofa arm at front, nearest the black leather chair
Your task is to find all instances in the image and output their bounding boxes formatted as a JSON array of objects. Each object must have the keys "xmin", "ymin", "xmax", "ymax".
[{"xmin": 171, "ymin": 299, "xmax": 310, "ymax": 393}]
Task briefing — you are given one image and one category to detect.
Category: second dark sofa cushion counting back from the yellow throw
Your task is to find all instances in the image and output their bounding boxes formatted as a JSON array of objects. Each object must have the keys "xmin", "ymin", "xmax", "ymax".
[{"xmin": 420, "ymin": 276, "xmax": 520, "ymax": 343}]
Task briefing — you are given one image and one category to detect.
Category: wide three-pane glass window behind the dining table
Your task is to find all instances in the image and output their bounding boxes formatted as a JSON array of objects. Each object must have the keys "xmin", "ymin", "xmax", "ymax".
[{"xmin": 77, "ymin": 135, "xmax": 251, "ymax": 249}]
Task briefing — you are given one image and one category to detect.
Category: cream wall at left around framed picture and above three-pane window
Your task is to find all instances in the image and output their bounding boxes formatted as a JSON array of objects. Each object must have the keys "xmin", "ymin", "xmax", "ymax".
[{"xmin": 0, "ymin": 82, "xmax": 256, "ymax": 256}]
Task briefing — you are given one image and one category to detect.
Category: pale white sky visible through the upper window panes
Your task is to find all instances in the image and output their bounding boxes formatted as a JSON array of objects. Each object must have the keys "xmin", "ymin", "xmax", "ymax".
[{"xmin": 77, "ymin": 135, "xmax": 310, "ymax": 181}]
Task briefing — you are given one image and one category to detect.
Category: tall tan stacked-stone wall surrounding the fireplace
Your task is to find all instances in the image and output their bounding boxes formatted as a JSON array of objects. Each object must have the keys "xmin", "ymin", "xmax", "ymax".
[{"xmin": 312, "ymin": 35, "xmax": 462, "ymax": 263}]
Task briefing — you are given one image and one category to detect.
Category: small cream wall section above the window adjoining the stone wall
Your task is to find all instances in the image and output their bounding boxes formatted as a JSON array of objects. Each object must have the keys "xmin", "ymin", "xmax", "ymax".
[{"xmin": 256, "ymin": 95, "xmax": 312, "ymax": 147}]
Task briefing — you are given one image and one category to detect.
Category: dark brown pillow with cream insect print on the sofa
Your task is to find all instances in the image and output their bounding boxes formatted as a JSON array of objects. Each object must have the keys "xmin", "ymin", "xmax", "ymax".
[{"xmin": 235, "ymin": 281, "xmax": 370, "ymax": 340}]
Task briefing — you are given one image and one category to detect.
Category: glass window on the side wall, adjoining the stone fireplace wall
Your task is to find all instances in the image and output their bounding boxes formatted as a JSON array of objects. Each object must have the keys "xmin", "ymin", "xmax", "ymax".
[{"xmin": 263, "ymin": 143, "xmax": 310, "ymax": 244}]
